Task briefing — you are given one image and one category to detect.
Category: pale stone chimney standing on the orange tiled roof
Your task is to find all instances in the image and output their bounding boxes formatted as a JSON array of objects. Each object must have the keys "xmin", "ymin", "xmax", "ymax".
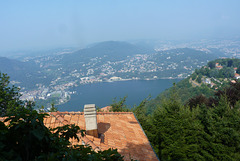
[{"xmin": 84, "ymin": 104, "xmax": 98, "ymax": 137}]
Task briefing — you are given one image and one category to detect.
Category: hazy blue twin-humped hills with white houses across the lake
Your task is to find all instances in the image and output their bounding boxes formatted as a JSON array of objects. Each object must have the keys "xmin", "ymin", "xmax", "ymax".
[{"xmin": 47, "ymin": 46, "xmax": 224, "ymax": 81}]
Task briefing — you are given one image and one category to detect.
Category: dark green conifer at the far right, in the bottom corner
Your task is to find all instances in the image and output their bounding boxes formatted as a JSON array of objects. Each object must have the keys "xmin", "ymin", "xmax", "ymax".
[{"xmin": 199, "ymin": 96, "xmax": 240, "ymax": 161}]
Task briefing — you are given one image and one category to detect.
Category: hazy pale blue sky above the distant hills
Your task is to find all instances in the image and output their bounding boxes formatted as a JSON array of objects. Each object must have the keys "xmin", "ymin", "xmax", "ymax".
[{"xmin": 0, "ymin": 0, "xmax": 240, "ymax": 51}]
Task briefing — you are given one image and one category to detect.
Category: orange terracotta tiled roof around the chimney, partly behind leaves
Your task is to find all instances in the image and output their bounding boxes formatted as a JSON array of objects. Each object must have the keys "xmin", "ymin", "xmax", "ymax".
[{"xmin": 44, "ymin": 112, "xmax": 158, "ymax": 161}]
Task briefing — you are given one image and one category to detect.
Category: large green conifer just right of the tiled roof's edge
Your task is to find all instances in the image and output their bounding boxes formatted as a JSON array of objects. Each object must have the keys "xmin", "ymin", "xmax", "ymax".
[{"xmin": 151, "ymin": 93, "xmax": 204, "ymax": 160}]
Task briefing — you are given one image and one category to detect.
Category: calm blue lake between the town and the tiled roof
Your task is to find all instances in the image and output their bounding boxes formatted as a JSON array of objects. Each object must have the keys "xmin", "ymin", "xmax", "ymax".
[{"xmin": 57, "ymin": 79, "xmax": 180, "ymax": 111}]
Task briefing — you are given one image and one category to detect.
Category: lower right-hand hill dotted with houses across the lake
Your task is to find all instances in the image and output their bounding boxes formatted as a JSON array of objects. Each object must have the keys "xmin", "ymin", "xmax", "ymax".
[{"xmin": 140, "ymin": 48, "xmax": 225, "ymax": 78}]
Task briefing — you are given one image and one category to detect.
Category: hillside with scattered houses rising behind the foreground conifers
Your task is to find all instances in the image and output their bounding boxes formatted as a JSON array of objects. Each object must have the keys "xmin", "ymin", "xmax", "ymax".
[{"xmin": 146, "ymin": 59, "xmax": 240, "ymax": 113}]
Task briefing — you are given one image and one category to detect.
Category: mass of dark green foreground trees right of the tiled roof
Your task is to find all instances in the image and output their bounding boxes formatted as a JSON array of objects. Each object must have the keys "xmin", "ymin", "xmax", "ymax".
[{"xmin": 140, "ymin": 82, "xmax": 240, "ymax": 161}]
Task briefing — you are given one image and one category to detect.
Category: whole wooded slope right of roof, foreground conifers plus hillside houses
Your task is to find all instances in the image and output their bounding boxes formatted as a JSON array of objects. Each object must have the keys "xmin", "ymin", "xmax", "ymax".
[{"xmin": 131, "ymin": 59, "xmax": 240, "ymax": 161}]
